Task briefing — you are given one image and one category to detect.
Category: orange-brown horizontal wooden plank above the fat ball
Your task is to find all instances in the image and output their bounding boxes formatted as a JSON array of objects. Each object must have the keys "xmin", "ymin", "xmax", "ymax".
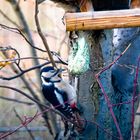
[{"xmin": 66, "ymin": 9, "xmax": 140, "ymax": 31}]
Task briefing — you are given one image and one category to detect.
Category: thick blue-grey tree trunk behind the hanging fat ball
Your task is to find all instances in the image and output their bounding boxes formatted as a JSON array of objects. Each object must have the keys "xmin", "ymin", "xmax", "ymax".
[{"xmin": 79, "ymin": 28, "xmax": 140, "ymax": 140}]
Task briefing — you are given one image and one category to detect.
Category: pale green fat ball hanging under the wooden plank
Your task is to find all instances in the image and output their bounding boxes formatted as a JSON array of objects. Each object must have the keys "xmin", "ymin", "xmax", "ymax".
[{"xmin": 68, "ymin": 32, "xmax": 90, "ymax": 75}]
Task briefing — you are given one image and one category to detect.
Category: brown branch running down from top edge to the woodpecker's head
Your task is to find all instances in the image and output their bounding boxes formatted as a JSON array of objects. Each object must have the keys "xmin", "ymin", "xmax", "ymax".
[{"xmin": 35, "ymin": 0, "xmax": 57, "ymax": 68}]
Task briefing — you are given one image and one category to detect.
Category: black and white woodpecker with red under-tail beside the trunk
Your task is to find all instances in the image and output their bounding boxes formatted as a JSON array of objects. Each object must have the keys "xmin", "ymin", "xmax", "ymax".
[{"xmin": 41, "ymin": 66, "xmax": 78, "ymax": 119}]
